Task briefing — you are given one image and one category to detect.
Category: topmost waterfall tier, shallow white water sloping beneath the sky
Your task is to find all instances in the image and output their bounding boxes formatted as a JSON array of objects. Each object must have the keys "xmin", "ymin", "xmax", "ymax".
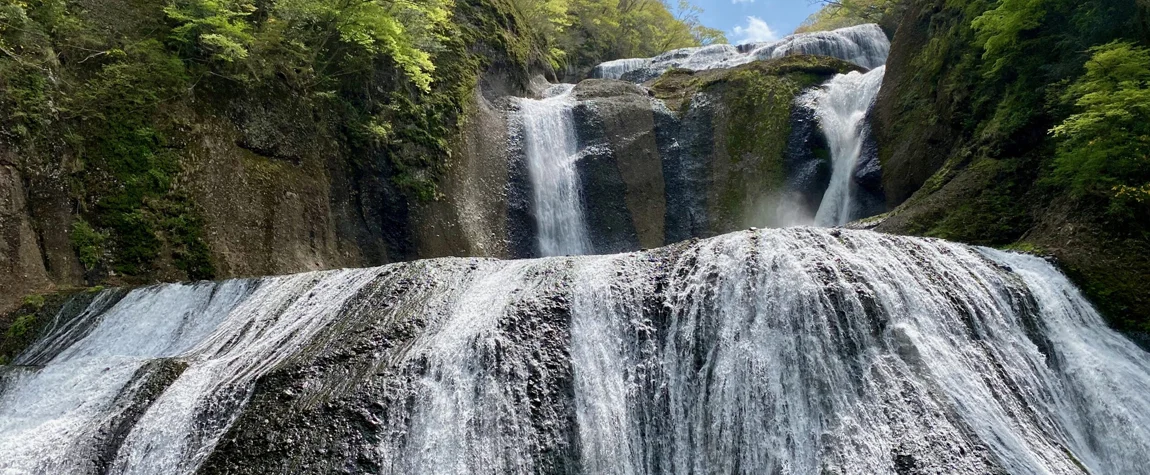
[{"xmin": 591, "ymin": 24, "xmax": 890, "ymax": 83}]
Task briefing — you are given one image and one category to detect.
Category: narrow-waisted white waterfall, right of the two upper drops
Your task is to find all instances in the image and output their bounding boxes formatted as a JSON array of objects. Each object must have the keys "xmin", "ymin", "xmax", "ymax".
[{"xmin": 798, "ymin": 66, "xmax": 887, "ymax": 227}]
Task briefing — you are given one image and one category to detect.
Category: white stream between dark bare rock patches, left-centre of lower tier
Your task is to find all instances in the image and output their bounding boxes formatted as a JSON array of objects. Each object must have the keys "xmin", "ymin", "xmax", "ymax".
[{"xmin": 378, "ymin": 261, "xmax": 538, "ymax": 474}]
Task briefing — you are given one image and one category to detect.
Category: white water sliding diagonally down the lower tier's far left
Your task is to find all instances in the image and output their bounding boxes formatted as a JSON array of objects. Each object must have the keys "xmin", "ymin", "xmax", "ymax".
[{"xmin": 0, "ymin": 269, "xmax": 378, "ymax": 474}]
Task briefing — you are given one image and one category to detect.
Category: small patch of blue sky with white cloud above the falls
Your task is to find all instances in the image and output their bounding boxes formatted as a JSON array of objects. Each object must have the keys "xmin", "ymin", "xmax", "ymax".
[{"xmin": 691, "ymin": 0, "xmax": 819, "ymax": 44}]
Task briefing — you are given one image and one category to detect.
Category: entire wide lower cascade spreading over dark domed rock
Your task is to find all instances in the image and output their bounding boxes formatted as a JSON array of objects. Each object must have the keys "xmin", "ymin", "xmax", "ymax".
[{"xmin": 0, "ymin": 228, "xmax": 1150, "ymax": 474}]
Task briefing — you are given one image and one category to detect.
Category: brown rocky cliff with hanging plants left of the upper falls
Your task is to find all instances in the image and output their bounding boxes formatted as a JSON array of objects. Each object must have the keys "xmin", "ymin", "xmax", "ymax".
[{"xmin": 0, "ymin": 0, "xmax": 542, "ymax": 309}]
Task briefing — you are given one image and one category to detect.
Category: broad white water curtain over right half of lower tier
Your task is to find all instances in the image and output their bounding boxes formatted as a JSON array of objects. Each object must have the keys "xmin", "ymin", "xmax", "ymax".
[{"xmin": 572, "ymin": 229, "xmax": 1150, "ymax": 475}]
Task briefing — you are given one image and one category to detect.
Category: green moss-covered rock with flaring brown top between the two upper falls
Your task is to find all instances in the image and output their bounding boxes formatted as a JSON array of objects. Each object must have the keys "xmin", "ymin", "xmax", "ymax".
[{"xmin": 651, "ymin": 55, "xmax": 863, "ymax": 236}]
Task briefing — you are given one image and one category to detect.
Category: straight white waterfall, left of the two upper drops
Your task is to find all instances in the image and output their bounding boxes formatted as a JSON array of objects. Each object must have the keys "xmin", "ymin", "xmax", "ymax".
[{"xmin": 519, "ymin": 84, "xmax": 591, "ymax": 256}]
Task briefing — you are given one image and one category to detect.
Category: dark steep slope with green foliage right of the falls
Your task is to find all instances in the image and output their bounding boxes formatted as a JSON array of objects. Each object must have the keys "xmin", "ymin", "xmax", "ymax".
[{"xmin": 877, "ymin": 0, "xmax": 1150, "ymax": 331}]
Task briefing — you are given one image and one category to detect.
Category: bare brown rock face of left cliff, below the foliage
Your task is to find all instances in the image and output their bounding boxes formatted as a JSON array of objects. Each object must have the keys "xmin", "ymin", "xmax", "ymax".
[{"xmin": 0, "ymin": 0, "xmax": 531, "ymax": 313}]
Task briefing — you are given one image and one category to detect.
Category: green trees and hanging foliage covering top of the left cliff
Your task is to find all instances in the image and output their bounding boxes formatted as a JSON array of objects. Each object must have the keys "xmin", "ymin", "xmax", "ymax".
[{"xmin": 0, "ymin": 0, "xmax": 721, "ymax": 288}]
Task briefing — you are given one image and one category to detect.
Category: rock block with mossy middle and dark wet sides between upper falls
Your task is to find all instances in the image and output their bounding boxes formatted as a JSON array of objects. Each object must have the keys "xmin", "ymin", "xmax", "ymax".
[{"xmin": 652, "ymin": 56, "xmax": 857, "ymax": 236}]
